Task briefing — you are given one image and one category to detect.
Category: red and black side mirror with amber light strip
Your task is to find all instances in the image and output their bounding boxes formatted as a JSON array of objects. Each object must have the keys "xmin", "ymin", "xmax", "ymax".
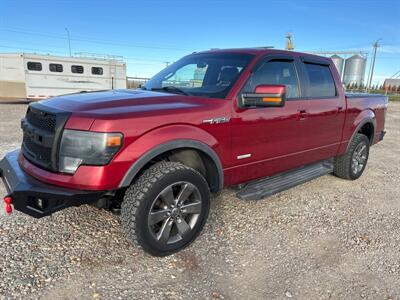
[{"xmin": 242, "ymin": 85, "xmax": 286, "ymax": 107}]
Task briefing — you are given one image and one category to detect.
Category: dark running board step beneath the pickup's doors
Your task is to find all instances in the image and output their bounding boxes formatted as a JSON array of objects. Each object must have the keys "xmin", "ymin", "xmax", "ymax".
[{"xmin": 236, "ymin": 160, "xmax": 333, "ymax": 200}]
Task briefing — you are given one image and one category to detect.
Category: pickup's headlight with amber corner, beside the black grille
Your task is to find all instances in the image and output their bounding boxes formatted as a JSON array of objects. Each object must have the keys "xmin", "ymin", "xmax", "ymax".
[{"xmin": 59, "ymin": 129, "xmax": 123, "ymax": 173}]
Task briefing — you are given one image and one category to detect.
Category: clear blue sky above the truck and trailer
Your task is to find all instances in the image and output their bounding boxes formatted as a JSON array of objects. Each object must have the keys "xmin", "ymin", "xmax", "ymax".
[{"xmin": 0, "ymin": 0, "xmax": 400, "ymax": 83}]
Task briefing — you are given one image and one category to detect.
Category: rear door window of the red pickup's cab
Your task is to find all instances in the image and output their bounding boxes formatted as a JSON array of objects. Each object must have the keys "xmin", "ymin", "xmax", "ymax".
[{"xmin": 304, "ymin": 63, "xmax": 336, "ymax": 98}]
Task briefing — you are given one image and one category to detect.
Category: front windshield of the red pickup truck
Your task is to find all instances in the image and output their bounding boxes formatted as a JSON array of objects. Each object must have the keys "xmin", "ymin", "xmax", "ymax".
[{"xmin": 142, "ymin": 53, "xmax": 254, "ymax": 98}]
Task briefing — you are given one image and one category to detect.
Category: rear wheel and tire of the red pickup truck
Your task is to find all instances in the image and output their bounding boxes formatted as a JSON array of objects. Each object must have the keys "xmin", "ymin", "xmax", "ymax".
[{"xmin": 333, "ymin": 133, "xmax": 369, "ymax": 180}]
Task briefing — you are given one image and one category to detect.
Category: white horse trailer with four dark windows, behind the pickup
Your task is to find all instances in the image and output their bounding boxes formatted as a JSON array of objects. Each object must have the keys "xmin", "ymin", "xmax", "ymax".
[{"xmin": 0, "ymin": 53, "xmax": 126, "ymax": 100}]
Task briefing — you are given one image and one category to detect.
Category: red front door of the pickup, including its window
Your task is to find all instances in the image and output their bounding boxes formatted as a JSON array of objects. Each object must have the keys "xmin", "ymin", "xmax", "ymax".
[{"xmin": 230, "ymin": 56, "xmax": 307, "ymax": 184}]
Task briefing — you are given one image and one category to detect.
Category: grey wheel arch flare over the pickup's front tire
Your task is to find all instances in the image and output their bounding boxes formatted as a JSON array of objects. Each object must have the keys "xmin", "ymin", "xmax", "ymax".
[{"xmin": 119, "ymin": 139, "xmax": 224, "ymax": 192}]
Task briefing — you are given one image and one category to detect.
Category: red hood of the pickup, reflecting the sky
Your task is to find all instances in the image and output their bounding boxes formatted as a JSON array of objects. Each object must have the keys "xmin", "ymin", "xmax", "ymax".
[{"xmin": 40, "ymin": 90, "xmax": 211, "ymax": 118}]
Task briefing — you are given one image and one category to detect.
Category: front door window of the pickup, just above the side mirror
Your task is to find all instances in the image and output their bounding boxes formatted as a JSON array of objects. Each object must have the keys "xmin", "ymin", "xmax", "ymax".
[{"xmin": 243, "ymin": 60, "xmax": 300, "ymax": 99}]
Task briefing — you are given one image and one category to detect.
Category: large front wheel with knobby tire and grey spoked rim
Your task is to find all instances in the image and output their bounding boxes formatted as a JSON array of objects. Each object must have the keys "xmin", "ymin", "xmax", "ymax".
[{"xmin": 121, "ymin": 161, "xmax": 210, "ymax": 256}]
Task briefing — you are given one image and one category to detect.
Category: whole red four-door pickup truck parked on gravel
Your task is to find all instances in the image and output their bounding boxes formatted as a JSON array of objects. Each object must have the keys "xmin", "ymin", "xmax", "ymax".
[{"xmin": 0, "ymin": 48, "xmax": 388, "ymax": 256}]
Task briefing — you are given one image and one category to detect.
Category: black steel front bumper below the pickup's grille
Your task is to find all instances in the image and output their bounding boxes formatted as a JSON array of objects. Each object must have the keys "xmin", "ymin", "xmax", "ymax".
[{"xmin": 0, "ymin": 150, "xmax": 105, "ymax": 218}]
